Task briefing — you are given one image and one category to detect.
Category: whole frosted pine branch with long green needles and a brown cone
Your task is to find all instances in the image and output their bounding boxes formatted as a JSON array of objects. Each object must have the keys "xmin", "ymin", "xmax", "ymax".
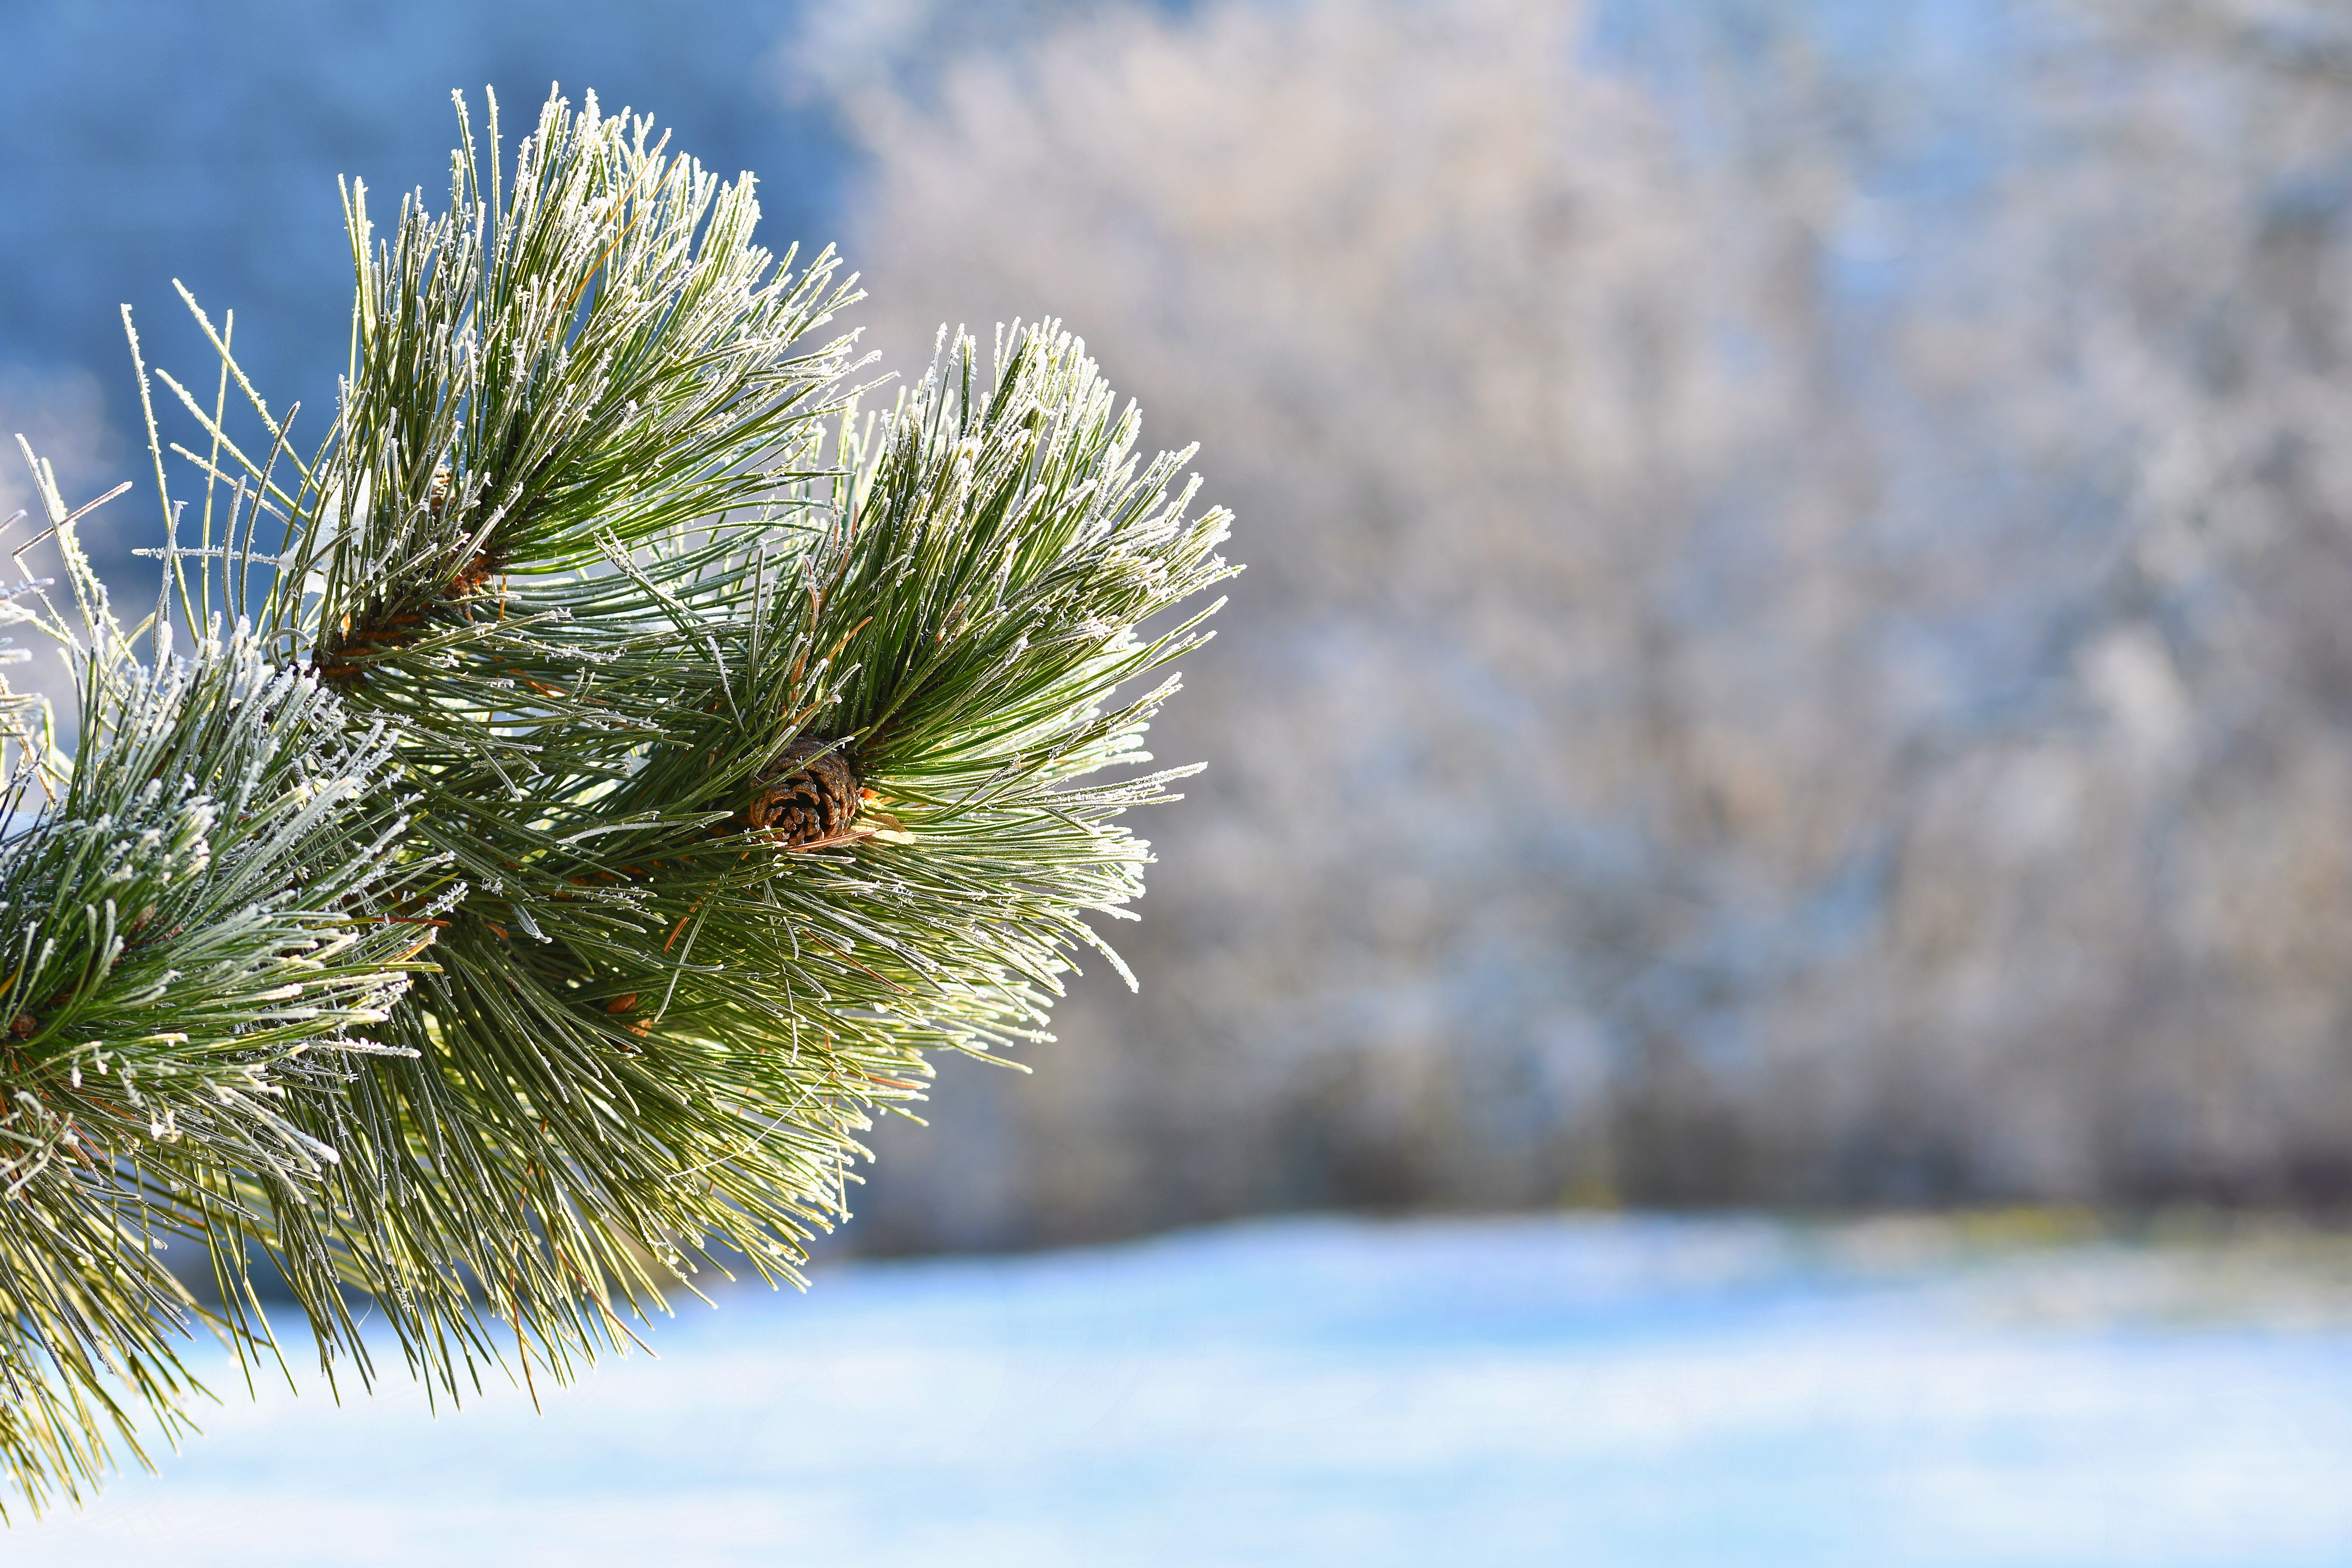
[{"xmin": 0, "ymin": 83, "xmax": 1230, "ymax": 1495}]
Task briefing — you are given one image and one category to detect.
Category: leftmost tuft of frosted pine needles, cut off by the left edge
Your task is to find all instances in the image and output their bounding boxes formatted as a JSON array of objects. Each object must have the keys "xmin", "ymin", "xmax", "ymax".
[{"xmin": 0, "ymin": 486, "xmax": 430, "ymax": 1507}]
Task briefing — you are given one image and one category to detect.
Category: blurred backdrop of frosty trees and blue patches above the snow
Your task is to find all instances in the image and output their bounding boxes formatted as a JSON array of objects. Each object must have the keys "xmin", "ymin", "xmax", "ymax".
[{"xmin": 0, "ymin": 0, "xmax": 2352, "ymax": 1248}]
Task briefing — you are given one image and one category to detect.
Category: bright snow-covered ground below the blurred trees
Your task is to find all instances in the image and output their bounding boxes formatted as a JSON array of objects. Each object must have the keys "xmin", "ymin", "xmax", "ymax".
[{"xmin": 14, "ymin": 1220, "xmax": 2352, "ymax": 1568}]
